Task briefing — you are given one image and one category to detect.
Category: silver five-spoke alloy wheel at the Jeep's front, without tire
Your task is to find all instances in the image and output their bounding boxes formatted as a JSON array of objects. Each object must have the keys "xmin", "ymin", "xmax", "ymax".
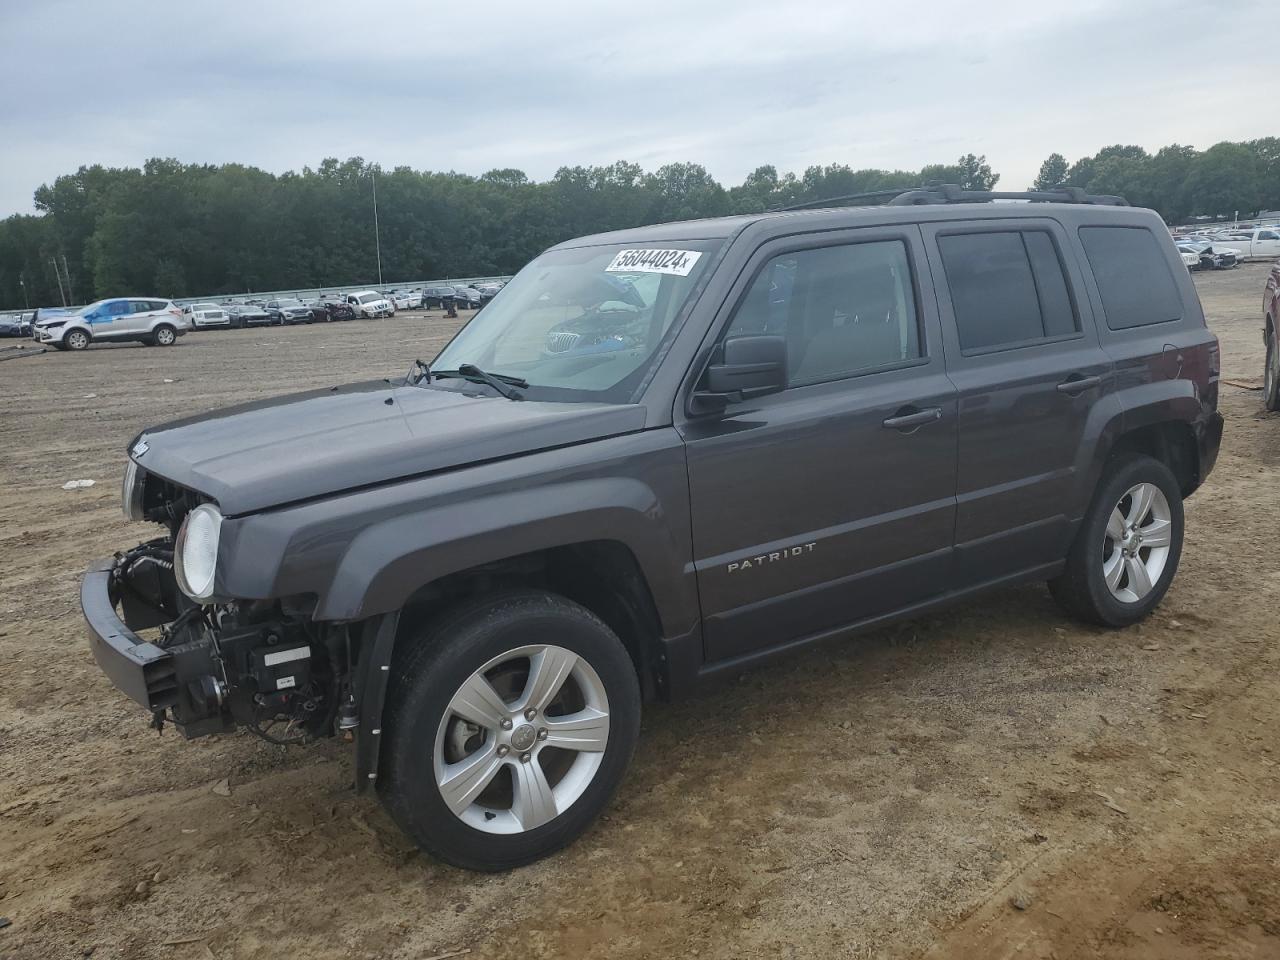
[{"xmin": 433, "ymin": 645, "xmax": 609, "ymax": 833}]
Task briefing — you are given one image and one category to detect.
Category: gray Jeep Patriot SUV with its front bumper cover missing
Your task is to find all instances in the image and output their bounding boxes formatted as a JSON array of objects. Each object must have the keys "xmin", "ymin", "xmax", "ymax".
[{"xmin": 81, "ymin": 187, "xmax": 1222, "ymax": 870}]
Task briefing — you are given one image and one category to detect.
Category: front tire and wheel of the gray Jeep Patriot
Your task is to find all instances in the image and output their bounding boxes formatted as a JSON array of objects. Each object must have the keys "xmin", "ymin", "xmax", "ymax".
[{"xmin": 378, "ymin": 591, "xmax": 640, "ymax": 872}]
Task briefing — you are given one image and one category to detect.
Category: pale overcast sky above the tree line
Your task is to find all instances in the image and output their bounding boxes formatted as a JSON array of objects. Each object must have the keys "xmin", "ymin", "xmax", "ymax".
[{"xmin": 0, "ymin": 0, "xmax": 1280, "ymax": 215}]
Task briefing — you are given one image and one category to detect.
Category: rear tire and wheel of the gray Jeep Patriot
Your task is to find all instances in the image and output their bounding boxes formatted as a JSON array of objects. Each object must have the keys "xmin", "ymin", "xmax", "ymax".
[{"xmin": 1050, "ymin": 453, "xmax": 1183, "ymax": 627}]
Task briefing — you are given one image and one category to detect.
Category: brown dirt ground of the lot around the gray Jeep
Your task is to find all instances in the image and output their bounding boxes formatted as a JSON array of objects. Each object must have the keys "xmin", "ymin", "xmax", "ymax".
[{"xmin": 0, "ymin": 265, "xmax": 1280, "ymax": 960}]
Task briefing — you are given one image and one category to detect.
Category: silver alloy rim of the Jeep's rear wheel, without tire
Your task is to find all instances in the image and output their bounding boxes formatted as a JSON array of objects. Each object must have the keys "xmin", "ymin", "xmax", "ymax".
[{"xmin": 1102, "ymin": 483, "xmax": 1174, "ymax": 603}]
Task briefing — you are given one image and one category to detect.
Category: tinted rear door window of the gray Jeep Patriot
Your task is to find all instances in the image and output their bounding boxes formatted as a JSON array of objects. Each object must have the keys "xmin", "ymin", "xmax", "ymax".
[{"xmin": 938, "ymin": 230, "xmax": 1080, "ymax": 353}]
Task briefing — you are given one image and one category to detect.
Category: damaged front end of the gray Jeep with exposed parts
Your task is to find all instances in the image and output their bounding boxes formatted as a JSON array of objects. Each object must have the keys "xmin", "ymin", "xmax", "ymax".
[{"xmin": 81, "ymin": 460, "xmax": 356, "ymax": 744}]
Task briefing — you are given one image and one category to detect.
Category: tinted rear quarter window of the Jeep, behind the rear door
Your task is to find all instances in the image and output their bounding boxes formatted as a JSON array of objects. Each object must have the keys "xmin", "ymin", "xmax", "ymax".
[{"xmin": 1080, "ymin": 227, "xmax": 1183, "ymax": 330}]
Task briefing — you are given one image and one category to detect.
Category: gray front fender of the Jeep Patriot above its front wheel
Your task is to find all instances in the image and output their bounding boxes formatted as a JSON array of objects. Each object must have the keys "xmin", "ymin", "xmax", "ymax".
[{"xmin": 219, "ymin": 428, "xmax": 698, "ymax": 636}]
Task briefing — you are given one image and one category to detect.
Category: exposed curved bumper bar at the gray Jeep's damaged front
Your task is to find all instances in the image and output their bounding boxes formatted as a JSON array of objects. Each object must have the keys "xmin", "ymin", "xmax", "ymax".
[{"xmin": 81, "ymin": 559, "xmax": 178, "ymax": 710}]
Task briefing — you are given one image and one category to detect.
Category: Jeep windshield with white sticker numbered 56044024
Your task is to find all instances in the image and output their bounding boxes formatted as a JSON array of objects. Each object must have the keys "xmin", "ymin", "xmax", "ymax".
[{"xmin": 431, "ymin": 239, "xmax": 723, "ymax": 403}]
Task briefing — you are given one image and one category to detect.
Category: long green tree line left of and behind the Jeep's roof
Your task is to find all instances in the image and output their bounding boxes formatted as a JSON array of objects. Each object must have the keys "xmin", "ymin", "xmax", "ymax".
[{"xmin": 0, "ymin": 155, "xmax": 998, "ymax": 308}]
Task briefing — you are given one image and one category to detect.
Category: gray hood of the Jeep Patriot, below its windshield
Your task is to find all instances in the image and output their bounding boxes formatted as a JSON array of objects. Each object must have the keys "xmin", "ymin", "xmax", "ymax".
[{"xmin": 129, "ymin": 380, "xmax": 645, "ymax": 516}]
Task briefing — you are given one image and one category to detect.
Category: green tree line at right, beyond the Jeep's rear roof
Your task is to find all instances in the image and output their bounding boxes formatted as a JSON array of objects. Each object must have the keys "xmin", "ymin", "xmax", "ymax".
[{"xmin": 1032, "ymin": 137, "xmax": 1280, "ymax": 224}]
